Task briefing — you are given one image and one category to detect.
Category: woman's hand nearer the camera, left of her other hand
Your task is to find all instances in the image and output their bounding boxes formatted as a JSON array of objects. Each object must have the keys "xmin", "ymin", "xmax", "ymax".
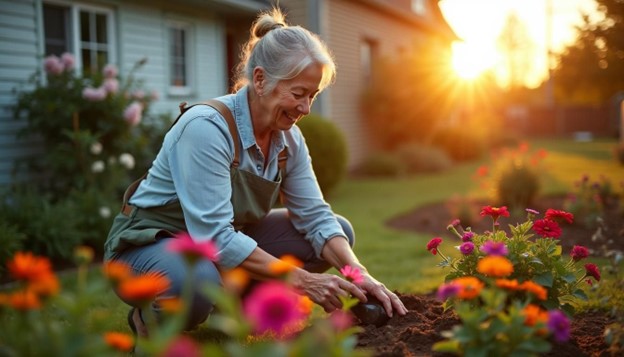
[{"xmin": 291, "ymin": 269, "xmax": 366, "ymax": 312}]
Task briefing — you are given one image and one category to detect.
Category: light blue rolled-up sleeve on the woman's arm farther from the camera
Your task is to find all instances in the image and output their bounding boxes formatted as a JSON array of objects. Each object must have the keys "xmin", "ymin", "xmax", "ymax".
[{"xmin": 282, "ymin": 126, "xmax": 347, "ymax": 258}]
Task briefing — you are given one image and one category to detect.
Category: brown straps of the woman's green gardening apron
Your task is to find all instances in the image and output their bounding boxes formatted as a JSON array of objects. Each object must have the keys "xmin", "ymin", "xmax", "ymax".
[{"xmin": 121, "ymin": 99, "xmax": 236, "ymax": 216}]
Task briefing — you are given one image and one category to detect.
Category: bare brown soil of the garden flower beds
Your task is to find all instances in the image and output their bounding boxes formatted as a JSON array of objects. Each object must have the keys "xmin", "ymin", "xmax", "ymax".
[{"xmin": 358, "ymin": 196, "xmax": 624, "ymax": 357}]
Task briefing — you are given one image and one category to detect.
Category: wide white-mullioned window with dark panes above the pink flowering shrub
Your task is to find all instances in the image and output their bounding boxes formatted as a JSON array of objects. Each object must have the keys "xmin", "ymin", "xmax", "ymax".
[{"xmin": 43, "ymin": 3, "xmax": 115, "ymax": 74}]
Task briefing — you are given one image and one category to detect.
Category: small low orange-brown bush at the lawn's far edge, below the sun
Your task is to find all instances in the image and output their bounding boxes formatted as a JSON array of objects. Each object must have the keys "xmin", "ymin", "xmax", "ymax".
[{"xmin": 396, "ymin": 143, "xmax": 453, "ymax": 173}]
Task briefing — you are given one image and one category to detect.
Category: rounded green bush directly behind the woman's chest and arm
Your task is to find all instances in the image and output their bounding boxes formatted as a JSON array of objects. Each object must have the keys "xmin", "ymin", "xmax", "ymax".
[{"xmin": 297, "ymin": 114, "xmax": 347, "ymax": 195}]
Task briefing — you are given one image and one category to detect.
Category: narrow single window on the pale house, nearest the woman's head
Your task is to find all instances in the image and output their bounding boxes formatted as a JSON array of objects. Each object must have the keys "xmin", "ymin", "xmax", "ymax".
[{"xmin": 168, "ymin": 21, "xmax": 191, "ymax": 95}]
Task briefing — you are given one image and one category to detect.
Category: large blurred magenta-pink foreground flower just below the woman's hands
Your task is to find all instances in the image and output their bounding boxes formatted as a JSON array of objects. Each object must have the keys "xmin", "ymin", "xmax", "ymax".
[{"xmin": 243, "ymin": 281, "xmax": 307, "ymax": 335}]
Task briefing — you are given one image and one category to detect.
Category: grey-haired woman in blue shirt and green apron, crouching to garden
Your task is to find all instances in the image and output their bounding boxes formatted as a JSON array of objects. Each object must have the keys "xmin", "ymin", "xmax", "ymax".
[{"xmin": 106, "ymin": 9, "xmax": 407, "ymax": 336}]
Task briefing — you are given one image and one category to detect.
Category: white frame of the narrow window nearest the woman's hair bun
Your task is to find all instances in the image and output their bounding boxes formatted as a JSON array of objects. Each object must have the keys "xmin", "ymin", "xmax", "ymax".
[{"xmin": 165, "ymin": 19, "xmax": 195, "ymax": 97}]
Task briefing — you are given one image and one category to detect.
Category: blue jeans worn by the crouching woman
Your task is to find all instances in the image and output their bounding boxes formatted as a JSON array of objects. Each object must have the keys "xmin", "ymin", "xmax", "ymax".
[{"xmin": 112, "ymin": 208, "xmax": 355, "ymax": 329}]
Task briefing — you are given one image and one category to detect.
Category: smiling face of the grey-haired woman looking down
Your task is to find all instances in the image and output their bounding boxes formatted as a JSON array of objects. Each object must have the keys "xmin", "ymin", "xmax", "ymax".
[{"xmin": 263, "ymin": 64, "xmax": 323, "ymax": 130}]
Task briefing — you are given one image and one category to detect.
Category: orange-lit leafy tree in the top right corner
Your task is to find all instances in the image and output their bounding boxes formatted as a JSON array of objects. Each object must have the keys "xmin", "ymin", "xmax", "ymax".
[{"xmin": 554, "ymin": 0, "xmax": 624, "ymax": 105}]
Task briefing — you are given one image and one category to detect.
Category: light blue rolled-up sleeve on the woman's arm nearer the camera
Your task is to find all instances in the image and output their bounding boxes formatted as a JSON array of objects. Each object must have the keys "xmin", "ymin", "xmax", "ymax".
[{"xmin": 168, "ymin": 107, "xmax": 257, "ymax": 268}]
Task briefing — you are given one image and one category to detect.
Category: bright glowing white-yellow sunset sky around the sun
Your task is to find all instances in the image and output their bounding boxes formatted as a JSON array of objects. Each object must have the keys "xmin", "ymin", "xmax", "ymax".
[{"xmin": 439, "ymin": 0, "xmax": 595, "ymax": 86}]
